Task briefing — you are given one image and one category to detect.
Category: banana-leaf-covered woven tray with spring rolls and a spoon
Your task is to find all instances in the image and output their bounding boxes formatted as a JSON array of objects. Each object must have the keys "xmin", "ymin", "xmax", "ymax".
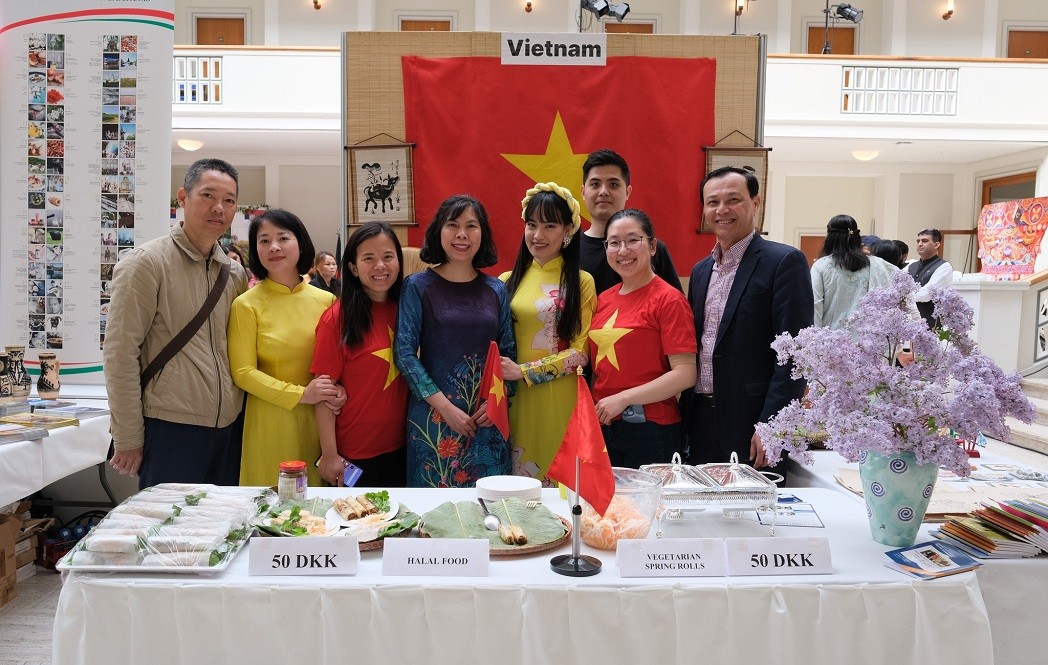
[{"xmin": 418, "ymin": 498, "xmax": 571, "ymax": 556}]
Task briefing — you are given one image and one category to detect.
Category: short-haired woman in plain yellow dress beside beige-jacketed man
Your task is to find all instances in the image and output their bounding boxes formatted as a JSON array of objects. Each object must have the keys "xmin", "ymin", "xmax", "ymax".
[{"xmin": 226, "ymin": 208, "xmax": 346, "ymax": 486}]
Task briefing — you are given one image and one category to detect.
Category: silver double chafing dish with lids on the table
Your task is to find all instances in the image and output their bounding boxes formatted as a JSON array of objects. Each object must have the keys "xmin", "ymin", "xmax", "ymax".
[{"xmin": 640, "ymin": 452, "xmax": 783, "ymax": 538}]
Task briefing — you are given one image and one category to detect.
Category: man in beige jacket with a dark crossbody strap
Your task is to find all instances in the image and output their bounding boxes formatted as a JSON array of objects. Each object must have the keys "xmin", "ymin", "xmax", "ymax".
[{"xmin": 103, "ymin": 159, "xmax": 247, "ymax": 488}]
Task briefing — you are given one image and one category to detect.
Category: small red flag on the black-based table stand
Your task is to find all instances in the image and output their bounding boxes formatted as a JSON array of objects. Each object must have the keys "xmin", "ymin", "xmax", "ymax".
[{"xmin": 546, "ymin": 374, "xmax": 615, "ymax": 515}]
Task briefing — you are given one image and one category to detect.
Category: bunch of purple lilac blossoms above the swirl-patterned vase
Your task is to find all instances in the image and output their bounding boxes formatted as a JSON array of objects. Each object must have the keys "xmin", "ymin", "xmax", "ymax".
[{"xmin": 757, "ymin": 271, "xmax": 1035, "ymax": 475}]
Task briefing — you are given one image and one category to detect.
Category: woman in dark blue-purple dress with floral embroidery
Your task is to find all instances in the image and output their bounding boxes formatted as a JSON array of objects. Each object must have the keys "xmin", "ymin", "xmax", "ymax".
[{"xmin": 393, "ymin": 195, "xmax": 517, "ymax": 487}]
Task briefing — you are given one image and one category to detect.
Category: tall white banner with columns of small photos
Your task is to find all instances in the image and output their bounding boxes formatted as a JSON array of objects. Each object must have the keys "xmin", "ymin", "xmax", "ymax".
[{"xmin": 0, "ymin": 0, "xmax": 174, "ymax": 383}]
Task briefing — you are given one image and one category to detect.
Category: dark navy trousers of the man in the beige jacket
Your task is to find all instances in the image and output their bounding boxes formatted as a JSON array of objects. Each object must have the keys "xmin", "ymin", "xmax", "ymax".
[{"xmin": 138, "ymin": 411, "xmax": 244, "ymax": 489}]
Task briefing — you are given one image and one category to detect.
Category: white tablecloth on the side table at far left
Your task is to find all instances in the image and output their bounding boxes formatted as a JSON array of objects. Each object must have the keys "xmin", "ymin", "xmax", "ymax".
[{"xmin": 0, "ymin": 402, "xmax": 109, "ymax": 506}]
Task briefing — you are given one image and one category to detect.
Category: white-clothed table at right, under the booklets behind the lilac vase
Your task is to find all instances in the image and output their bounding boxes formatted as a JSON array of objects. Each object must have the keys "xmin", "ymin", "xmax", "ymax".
[{"xmin": 786, "ymin": 442, "xmax": 1048, "ymax": 665}]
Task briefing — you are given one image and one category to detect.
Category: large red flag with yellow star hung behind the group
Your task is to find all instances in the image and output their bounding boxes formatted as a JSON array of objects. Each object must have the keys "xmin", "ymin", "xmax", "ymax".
[{"xmin": 402, "ymin": 56, "xmax": 717, "ymax": 274}]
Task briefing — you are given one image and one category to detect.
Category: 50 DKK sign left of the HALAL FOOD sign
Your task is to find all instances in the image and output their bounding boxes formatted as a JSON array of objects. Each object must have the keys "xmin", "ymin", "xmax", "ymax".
[{"xmin": 247, "ymin": 536, "xmax": 361, "ymax": 575}]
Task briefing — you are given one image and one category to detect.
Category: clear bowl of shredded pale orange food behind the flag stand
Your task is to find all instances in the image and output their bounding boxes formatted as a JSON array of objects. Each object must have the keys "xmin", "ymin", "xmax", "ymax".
[{"xmin": 578, "ymin": 466, "xmax": 662, "ymax": 550}]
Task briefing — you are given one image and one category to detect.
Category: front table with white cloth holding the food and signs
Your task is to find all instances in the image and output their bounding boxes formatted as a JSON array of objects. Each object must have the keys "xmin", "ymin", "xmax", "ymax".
[{"xmin": 53, "ymin": 489, "xmax": 992, "ymax": 665}]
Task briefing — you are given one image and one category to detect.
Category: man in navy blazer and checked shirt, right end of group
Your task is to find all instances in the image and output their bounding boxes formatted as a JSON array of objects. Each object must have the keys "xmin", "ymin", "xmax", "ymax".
[{"xmin": 681, "ymin": 167, "xmax": 814, "ymax": 472}]
